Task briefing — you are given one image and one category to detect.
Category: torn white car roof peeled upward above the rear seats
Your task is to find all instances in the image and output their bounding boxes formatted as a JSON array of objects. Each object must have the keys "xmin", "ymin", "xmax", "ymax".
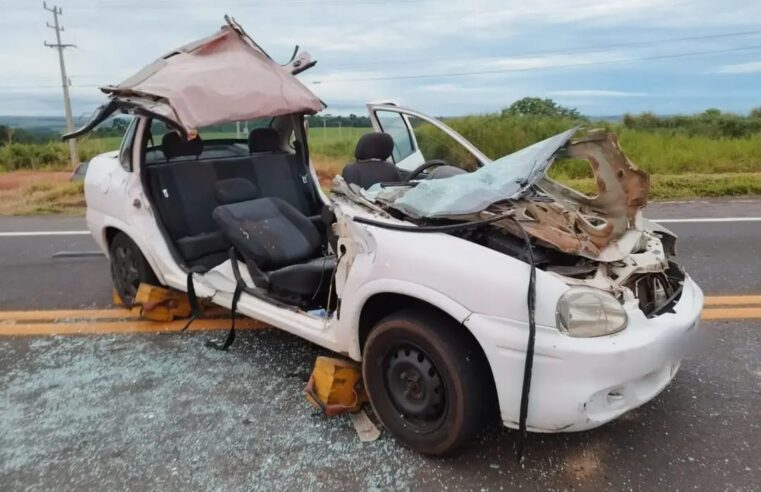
[{"xmin": 64, "ymin": 19, "xmax": 325, "ymax": 139}]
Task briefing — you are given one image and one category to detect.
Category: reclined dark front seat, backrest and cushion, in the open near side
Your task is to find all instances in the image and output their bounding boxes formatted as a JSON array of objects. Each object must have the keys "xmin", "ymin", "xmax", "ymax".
[{"xmin": 213, "ymin": 197, "xmax": 336, "ymax": 307}]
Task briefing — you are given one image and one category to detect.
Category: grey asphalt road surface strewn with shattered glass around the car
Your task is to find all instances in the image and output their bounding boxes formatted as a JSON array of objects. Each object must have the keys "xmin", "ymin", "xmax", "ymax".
[{"xmin": 0, "ymin": 200, "xmax": 761, "ymax": 490}]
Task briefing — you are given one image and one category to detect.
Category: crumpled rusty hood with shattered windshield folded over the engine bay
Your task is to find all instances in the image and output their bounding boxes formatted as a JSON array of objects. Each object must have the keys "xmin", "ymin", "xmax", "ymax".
[{"xmin": 354, "ymin": 128, "xmax": 652, "ymax": 262}]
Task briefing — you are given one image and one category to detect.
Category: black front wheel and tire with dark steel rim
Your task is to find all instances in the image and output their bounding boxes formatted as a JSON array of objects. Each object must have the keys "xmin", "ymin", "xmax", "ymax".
[{"xmin": 362, "ymin": 310, "xmax": 494, "ymax": 456}]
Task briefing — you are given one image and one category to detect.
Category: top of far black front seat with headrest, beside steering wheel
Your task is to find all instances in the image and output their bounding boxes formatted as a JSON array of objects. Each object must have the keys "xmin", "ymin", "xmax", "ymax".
[{"xmin": 341, "ymin": 133, "xmax": 402, "ymax": 189}]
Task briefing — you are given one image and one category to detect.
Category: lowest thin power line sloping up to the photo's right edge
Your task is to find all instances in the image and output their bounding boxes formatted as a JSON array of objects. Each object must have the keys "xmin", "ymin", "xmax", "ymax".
[{"xmin": 311, "ymin": 45, "xmax": 761, "ymax": 84}]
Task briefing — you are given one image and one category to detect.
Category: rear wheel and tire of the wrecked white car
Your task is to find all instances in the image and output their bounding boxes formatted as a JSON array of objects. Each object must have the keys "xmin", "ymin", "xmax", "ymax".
[{"xmin": 108, "ymin": 232, "xmax": 158, "ymax": 308}]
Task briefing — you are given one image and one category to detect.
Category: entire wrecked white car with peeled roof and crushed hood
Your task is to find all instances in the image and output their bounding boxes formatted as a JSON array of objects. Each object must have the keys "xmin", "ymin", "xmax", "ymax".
[{"xmin": 69, "ymin": 22, "xmax": 703, "ymax": 454}]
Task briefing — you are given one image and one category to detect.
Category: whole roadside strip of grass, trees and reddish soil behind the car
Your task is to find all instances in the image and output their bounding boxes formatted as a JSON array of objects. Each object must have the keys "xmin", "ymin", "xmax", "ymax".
[{"xmin": 0, "ymin": 98, "xmax": 761, "ymax": 214}]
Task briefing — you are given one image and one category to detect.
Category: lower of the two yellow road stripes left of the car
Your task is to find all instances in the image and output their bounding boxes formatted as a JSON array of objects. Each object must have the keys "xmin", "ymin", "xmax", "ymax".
[{"xmin": 0, "ymin": 318, "xmax": 267, "ymax": 336}]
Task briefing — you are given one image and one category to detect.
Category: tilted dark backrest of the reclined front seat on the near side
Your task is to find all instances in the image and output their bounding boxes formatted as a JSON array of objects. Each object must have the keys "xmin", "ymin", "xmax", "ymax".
[{"xmin": 213, "ymin": 198, "xmax": 322, "ymax": 272}]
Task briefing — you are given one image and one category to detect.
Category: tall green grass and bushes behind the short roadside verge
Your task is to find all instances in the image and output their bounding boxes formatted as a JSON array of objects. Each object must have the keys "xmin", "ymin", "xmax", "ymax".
[{"xmin": 0, "ymin": 114, "xmax": 761, "ymax": 179}]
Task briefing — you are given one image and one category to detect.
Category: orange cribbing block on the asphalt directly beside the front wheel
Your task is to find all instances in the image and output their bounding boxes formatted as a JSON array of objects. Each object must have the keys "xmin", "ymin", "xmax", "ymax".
[{"xmin": 305, "ymin": 357, "xmax": 367, "ymax": 416}]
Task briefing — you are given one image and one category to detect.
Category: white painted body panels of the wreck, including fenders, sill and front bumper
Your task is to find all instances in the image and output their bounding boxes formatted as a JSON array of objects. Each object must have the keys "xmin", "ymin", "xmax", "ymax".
[{"xmin": 85, "ymin": 106, "xmax": 703, "ymax": 432}]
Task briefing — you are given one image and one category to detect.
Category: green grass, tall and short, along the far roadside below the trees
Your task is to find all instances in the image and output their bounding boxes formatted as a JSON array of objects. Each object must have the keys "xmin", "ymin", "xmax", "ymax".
[{"xmin": 0, "ymin": 114, "xmax": 761, "ymax": 211}]
